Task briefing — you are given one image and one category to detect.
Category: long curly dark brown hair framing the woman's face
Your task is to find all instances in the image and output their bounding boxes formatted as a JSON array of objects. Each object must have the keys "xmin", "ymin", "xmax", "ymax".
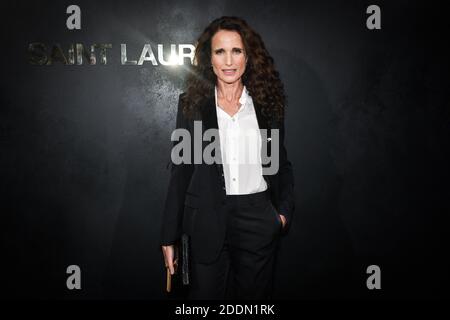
[{"xmin": 181, "ymin": 16, "xmax": 286, "ymax": 120}]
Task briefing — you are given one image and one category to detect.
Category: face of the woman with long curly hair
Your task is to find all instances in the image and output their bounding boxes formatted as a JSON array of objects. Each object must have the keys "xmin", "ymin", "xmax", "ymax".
[{"xmin": 211, "ymin": 30, "xmax": 247, "ymax": 83}]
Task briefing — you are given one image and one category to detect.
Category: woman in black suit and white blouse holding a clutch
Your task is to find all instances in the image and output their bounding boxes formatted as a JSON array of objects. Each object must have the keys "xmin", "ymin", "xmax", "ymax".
[{"xmin": 162, "ymin": 17, "xmax": 295, "ymax": 299}]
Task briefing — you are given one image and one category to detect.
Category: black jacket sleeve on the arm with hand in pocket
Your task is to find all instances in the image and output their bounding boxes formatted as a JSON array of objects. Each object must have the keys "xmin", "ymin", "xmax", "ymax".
[{"xmin": 278, "ymin": 118, "xmax": 295, "ymax": 231}]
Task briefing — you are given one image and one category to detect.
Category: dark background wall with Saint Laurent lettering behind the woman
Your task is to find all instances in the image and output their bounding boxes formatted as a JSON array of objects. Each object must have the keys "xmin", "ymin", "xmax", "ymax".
[{"xmin": 0, "ymin": 0, "xmax": 449, "ymax": 299}]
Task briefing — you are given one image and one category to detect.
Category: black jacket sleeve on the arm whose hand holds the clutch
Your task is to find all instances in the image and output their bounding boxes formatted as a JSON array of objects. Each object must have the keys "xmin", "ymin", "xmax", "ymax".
[{"xmin": 161, "ymin": 93, "xmax": 193, "ymax": 245}]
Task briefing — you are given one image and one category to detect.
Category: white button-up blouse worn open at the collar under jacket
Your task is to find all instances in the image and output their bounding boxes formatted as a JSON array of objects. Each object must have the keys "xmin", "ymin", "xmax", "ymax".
[{"xmin": 215, "ymin": 86, "xmax": 267, "ymax": 195}]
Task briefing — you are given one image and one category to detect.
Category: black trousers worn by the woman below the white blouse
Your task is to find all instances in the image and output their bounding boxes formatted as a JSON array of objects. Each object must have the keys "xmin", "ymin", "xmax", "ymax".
[{"xmin": 188, "ymin": 190, "xmax": 282, "ymax": 300}]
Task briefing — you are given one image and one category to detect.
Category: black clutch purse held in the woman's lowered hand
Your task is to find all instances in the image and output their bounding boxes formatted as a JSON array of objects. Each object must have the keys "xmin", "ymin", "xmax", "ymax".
[{"xmin": 166, "ymin": 234, "xmax": 190, "ymax": 293}]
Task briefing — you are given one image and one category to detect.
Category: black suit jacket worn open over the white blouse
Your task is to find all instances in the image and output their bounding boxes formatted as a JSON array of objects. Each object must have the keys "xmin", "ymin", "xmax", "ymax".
[{"xmin": 161, "ymin": 91, "xmax": 295, "ymax": 263}]
